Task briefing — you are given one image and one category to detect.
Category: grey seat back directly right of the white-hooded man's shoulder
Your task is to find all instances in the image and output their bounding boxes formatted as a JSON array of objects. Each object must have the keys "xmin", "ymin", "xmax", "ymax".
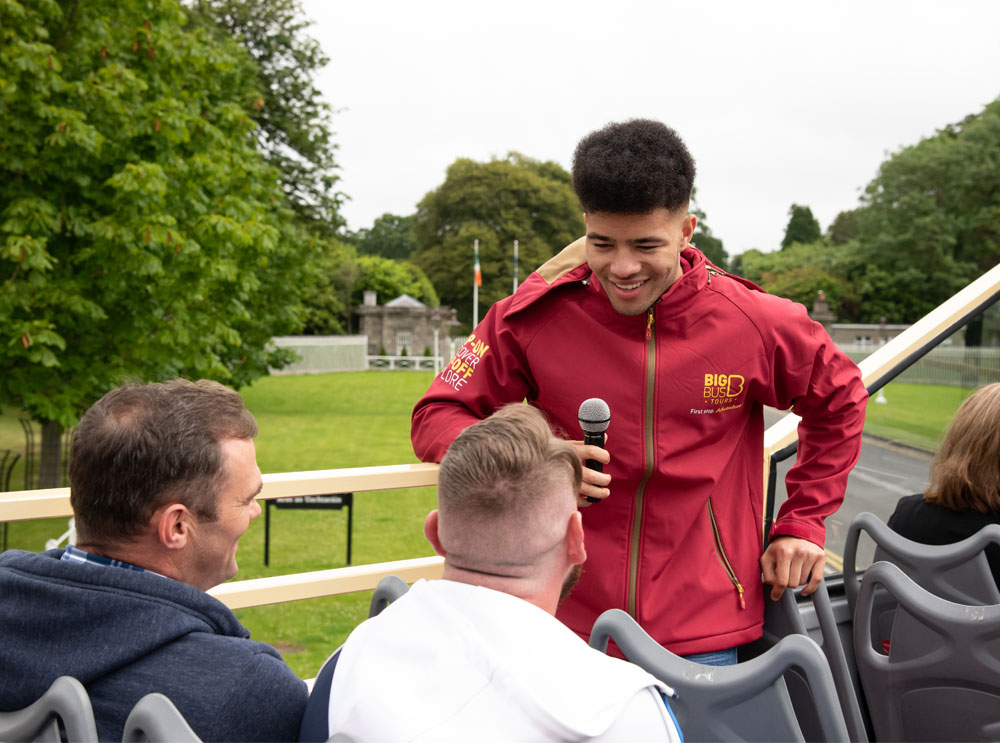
[{"xmin": 590, "ymin": 609, "xmax": 848, "ymax": 741}]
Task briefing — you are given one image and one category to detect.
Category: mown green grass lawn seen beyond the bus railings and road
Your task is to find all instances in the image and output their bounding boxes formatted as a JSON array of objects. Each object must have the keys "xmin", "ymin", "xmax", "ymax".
[{"xmin": 0, "ymin": 372, "xmax": 984, "ymax": 678}]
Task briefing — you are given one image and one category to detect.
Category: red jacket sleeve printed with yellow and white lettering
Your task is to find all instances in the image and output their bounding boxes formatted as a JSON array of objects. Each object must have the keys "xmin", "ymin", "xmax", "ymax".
[{"xmin": 410, "ymin": 301, "xmax": 534, "ymax": 462}]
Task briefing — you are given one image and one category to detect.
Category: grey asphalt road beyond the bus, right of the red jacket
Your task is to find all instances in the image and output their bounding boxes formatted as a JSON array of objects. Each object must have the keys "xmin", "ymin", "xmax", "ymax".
[{"xmin": 764, "ymin": 409, "xmax": 932, "ymax": 573}]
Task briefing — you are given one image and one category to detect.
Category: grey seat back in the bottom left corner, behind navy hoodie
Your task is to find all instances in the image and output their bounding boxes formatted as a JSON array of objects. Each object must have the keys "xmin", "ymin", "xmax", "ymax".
[{"xmin": 0, "ymin": 676, "xmax": 97, "ymax": 743}]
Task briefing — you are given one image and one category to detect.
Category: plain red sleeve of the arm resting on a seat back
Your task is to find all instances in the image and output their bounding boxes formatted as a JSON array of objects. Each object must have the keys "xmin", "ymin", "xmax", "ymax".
[{"xmin": 768, "ymin": 311, "xmax": 868, "ymax": 547}]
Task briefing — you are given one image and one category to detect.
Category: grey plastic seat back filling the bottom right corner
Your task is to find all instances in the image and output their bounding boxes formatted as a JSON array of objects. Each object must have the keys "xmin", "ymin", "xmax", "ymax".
[{"xmin": 854, "ymin": 562, "xmax": 1000, "ymax": 741}]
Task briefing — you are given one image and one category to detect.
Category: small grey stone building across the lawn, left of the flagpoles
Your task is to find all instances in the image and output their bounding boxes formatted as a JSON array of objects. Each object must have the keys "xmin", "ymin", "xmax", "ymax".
[{"xmin": 356, "ymin": 291, "xmax": 458, "ymax": 356}]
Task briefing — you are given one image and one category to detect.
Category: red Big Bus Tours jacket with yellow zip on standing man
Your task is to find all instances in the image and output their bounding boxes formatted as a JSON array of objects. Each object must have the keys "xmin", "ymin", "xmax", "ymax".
[{"xmin": 412, "ymin": 240, "xmax": 867, "ymax": 654}]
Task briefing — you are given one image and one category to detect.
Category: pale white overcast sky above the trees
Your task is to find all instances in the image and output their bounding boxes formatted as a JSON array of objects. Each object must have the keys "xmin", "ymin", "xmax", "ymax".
[{"xmin": 303, "ymin": 0, "xmax": 1000, "ymax": 255}]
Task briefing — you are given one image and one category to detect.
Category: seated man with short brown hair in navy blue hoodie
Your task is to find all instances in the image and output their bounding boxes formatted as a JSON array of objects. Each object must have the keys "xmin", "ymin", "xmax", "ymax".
[{"xmin": 0, "ymin": 379, "xmax": 306, "ymax": 741}]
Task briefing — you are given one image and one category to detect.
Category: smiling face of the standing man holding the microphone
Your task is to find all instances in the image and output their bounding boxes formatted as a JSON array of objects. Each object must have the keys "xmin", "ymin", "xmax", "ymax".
[{"xmin": 584, "ymin": 208, "xmax": 698, "ymax": 315}]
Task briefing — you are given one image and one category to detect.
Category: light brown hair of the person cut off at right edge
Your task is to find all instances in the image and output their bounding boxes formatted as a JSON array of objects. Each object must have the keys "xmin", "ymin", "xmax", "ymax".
[{"xmin": 924, "ymin": 382, "xmax": 1000, "ymax": 516}]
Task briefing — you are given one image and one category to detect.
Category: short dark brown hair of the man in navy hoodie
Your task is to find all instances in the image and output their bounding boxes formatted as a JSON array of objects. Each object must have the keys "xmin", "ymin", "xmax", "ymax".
[{"xmin": 69, "ymin": 379, "xmax": 257, "ymax": 544}]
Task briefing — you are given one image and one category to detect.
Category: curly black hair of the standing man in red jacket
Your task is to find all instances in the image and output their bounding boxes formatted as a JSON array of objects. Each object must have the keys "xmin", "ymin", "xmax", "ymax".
[{"xmin": 573, "ymin": 119, "xmax": 695, "ymax": 214}]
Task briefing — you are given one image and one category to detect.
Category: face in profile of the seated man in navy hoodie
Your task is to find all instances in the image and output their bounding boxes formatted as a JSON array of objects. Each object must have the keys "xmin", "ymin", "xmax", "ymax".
[{"xmin": 184, "ymin": 439, "xmax": 262, "ymax": 591}]
